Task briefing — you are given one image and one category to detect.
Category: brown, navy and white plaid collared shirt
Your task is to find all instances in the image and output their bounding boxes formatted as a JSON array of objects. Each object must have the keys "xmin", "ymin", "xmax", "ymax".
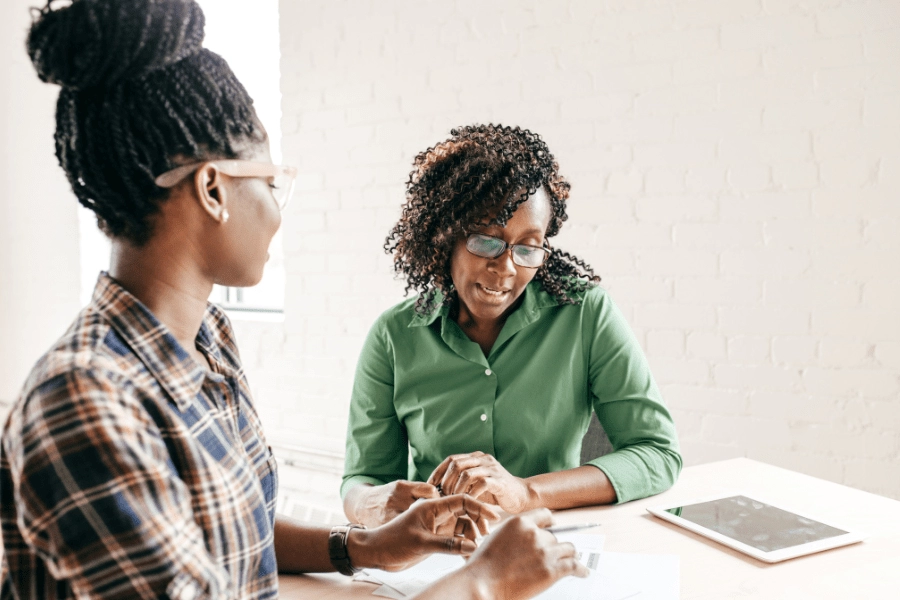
[{"xmin": 0, "ymin": 273, "xmax": 278, "ymax": 600}]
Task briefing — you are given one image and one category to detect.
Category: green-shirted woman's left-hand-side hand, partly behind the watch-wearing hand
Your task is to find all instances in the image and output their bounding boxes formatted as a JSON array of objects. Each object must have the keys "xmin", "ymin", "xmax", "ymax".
[{"xmin": 345, "ymin": 479, "xmax": 441, "ymax": 527}]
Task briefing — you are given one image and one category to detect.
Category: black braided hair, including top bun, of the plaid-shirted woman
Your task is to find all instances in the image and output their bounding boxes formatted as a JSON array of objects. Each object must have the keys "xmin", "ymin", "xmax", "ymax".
[{"xmin": 27, "ymin": 0, "xmax": 266, "ymax": 245}]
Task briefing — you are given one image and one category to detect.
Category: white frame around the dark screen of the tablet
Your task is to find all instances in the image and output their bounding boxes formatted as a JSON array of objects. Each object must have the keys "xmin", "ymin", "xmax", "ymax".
[{"xmin": 647, "ymin": 491, "xmax": 868, "ymax": 563}]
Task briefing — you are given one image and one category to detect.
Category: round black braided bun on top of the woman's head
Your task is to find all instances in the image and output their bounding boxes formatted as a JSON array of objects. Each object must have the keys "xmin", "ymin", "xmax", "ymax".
[{"xmin": 27, "ymin": 0, "xmax": 205, "ymax": 90}]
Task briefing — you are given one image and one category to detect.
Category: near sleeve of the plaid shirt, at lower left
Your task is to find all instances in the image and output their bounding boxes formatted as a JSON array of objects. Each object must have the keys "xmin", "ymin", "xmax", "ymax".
[{"xmin": 3, "ymin": 369, "xmax": 230, "ymax": 598}]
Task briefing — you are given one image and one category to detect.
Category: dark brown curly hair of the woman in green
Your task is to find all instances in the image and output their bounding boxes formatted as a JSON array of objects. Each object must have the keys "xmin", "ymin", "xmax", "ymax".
[{"xmin": 384, "ymin": 124, "xmax": 600, "ymax": 314}]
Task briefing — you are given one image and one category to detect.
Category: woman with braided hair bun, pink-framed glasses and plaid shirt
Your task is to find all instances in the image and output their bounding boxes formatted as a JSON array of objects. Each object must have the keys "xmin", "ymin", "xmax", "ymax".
[{"xmin": 0, "ymin": 0, "xmax": 586, "ymax": 600}]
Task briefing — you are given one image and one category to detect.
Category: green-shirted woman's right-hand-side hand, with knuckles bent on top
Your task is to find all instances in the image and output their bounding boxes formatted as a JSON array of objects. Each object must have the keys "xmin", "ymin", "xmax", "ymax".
[{"xmin": 428, "ymin": 452, "xmax": 535, "ymax": 514}]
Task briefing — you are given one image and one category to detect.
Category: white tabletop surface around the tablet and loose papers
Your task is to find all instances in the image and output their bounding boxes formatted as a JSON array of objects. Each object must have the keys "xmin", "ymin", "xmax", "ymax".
[{"xmin": 280, "ymin": 458, "xmax": 900, "ymax": 600}]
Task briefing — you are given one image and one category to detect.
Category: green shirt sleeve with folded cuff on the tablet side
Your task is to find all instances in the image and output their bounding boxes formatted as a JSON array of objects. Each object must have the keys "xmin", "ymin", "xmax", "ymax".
[{"xmin": 584, "ymin": 290, "xmax": 682, "ymax": 503}]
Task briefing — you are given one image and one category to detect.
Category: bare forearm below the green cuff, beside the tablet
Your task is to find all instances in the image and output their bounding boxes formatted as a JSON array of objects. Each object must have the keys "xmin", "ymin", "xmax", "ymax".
[{"xmin": 525, "ymin": 465, "xmax": 616, "ymax": 510}]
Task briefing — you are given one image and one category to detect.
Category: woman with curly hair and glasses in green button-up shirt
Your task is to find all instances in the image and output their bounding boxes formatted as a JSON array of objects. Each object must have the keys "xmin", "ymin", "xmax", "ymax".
[{"xmin": 341, "ymin": 125, "xmax": 681, "ymax": 525}]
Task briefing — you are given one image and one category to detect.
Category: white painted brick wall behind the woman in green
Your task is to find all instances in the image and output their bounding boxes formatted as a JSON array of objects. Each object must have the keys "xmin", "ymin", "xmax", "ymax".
[{"xmin": 260, "ymin": 0, "xmax": 900, "ymax": 498}]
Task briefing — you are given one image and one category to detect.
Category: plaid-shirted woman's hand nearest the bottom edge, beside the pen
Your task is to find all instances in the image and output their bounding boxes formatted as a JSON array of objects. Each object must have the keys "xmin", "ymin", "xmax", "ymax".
[{"xmin": 460, "ymin": 508, "xmax": 589, "ymax": 600}]
